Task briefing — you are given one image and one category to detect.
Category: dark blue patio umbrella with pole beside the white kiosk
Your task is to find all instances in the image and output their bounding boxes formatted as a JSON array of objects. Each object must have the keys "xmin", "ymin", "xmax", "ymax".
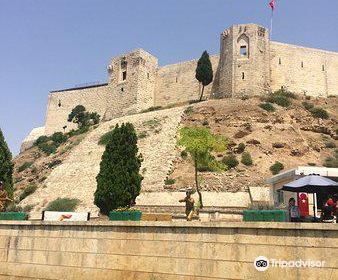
[{"xmin": 281, "ymin": 174, "xmax": 338, "ymax": 218}]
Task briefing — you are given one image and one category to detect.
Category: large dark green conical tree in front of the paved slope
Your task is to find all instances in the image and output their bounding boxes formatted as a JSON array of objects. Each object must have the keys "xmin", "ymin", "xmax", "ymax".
[{"xmin": 94, "ymin": 123, "xmax": 143, "ymax": 215}]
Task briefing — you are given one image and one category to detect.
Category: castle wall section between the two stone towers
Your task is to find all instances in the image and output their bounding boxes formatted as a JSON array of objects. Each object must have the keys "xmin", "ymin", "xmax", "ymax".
[{"xmin": 154, "ymin": 54, "xmax": 219, "ymax": 106}]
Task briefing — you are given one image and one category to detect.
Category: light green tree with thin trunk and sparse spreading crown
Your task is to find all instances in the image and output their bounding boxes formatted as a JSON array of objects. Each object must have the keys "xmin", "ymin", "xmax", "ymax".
[{"xmin": 177, "ymin": 127, "xmax": 229, "ymax": 208}]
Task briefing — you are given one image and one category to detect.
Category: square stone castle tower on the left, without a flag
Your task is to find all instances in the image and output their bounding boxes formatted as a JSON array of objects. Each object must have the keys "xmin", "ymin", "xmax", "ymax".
[{"xmin": 105, "ymin": 49, "xmax": 157, "ymax": 119}]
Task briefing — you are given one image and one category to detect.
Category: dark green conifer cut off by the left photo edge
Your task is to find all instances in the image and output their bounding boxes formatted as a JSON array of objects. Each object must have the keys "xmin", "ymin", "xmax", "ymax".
[{"xmin": 0, "ymin": 129, "xmax": 14, "ymax": 198}]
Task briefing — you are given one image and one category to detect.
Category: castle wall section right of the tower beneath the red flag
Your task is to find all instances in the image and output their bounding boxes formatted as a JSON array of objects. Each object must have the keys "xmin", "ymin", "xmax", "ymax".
[{"xmin": 270, "ymin": 42, "xmax": 338, "ymax": 97}]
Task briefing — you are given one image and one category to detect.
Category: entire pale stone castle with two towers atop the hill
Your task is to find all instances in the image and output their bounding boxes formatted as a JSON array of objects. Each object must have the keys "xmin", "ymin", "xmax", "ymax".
[{"xmin": 22, "ymin": 24, "xmax": 338, "ymax": 150}]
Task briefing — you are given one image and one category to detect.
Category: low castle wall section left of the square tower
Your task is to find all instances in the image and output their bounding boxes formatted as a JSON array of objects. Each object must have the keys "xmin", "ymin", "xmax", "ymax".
[{"xmin": 45, "ymin": 85, "xmax": 109, "ymax": 135}]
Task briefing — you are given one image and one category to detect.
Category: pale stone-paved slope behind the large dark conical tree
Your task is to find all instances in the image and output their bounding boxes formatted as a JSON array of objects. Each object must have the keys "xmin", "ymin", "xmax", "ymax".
[{"xmin": 14, "ymin": 107, "xmax": 184, "ymax": 215}]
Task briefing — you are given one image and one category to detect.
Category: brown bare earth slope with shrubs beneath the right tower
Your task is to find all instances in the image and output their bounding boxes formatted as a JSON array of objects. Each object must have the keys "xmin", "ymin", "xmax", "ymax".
[{"xmin": 165, "ymin": 98, "xmax": 338, "ymax": 192}]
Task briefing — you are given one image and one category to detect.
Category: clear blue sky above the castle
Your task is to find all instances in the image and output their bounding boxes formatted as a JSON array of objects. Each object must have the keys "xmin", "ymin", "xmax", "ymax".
[{"xmin": 0, "ymin": 0, "xmax": 338, "ymax": 154}]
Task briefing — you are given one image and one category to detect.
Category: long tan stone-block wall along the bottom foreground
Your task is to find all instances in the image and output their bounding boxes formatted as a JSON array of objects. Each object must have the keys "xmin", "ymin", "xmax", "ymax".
[{"xmin": 0, "ymin": 221, "xmax": 338, "ymax": 280}]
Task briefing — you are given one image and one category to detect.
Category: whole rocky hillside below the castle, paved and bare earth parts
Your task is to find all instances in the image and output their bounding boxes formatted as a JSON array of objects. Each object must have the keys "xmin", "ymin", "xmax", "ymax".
[{"xmin": 14, "ymin": 94, "xmax": 338, "ymax": 213}]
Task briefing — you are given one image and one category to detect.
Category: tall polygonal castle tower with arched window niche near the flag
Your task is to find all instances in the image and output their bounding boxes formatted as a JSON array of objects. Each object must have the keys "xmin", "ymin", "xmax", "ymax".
[{"xmin": 219, "ymin": 24, "xmax": 270, "ymax": 97}]
